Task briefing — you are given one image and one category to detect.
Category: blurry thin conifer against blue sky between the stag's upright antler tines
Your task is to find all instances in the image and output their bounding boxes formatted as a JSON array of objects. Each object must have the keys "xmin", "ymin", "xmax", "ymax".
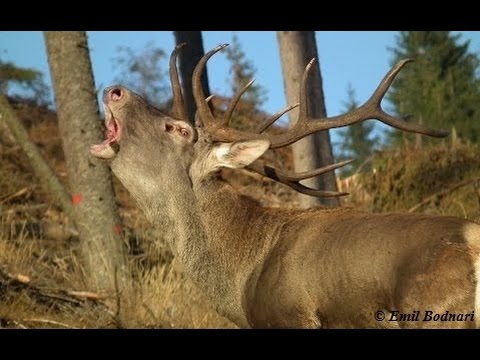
[{"xmin": 225, "ymin": 34, "xmax": 266, "ymax": 111}]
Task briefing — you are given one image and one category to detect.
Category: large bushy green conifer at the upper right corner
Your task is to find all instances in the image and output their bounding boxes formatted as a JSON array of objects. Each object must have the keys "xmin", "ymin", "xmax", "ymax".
[{"xmin": 389, "ymin": 31, "xmax": 480, "ymax": 145}]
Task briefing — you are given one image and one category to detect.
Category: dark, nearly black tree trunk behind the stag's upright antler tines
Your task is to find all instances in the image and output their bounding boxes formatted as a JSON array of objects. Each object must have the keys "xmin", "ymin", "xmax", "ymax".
[{"xmin": 173, "ymin": 31, "xmax": 210, "ymax": 124}]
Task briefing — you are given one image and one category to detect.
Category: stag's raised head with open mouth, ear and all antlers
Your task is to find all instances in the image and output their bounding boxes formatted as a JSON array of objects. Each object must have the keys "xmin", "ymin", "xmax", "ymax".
[{"xmin": 91, "ymin": 44, "xmax": 448, "ymax": 202}]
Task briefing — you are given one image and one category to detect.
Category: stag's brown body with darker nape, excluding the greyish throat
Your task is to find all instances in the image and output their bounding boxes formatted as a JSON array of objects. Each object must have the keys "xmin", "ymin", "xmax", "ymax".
[{"xmin": 190, "ymin": 173, "xmax": 480, "ymax": 328}]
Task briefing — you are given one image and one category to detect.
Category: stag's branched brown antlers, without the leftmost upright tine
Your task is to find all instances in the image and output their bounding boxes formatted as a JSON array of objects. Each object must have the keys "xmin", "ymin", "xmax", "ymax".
[{"xmin": 192, "ymin": 44, "xmax": 448, "ymax": 197}]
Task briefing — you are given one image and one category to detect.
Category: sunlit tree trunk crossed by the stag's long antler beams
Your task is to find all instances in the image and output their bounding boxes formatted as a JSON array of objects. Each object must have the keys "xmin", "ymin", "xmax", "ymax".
[{"xmin": 277, "ymin": 31, "xmax": 340, "ymax": 208}]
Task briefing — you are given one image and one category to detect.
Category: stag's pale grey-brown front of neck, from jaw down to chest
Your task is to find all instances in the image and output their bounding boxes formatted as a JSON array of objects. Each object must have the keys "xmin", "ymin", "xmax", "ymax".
[{"xmin": 115, "ymin": 160, "xmax": 255, "ymax": 326}]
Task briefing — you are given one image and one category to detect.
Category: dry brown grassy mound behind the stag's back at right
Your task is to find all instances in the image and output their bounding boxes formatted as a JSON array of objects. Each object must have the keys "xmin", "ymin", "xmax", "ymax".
[{"xmin": 342, "ymin": 142, "xmax": 480, "ymax": 220}]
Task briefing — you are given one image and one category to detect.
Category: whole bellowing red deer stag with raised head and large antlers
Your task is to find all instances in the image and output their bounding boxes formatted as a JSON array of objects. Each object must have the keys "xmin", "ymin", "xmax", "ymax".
[{"xmin": 91, "ymin": 45, "xmax": 480, "ymax": 328}]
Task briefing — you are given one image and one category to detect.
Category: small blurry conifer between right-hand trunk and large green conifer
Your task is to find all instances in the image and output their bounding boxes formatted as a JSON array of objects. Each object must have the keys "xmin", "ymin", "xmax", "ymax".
[{"xmin": 338, "ymin": 84, "xmax": 379, "ymax": 176}]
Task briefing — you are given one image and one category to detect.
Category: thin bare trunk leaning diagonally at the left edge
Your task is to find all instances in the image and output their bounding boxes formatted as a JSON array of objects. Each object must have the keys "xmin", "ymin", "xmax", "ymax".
[{"xmin": 0, "ymin": 94, "xmax": 75, "ymax": 219}]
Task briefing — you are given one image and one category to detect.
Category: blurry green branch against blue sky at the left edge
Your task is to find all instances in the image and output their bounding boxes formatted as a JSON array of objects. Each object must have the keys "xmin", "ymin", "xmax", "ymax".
[{"xmin": 0, "ymin": 59, "xmax": 50, "ymax": 105}]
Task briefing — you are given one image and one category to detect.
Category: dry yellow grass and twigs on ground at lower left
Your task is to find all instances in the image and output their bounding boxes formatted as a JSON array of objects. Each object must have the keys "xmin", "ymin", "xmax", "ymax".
[{"xmin": 0, "ymin": 218, "xmax": 234, "ymax": 328}]
